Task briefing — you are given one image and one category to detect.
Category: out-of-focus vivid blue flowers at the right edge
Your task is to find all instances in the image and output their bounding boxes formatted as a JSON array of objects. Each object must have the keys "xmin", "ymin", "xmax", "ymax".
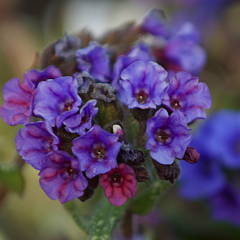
[{"xmin": 180, "ymin": 110, "xmax": 240, "ymax": 224}]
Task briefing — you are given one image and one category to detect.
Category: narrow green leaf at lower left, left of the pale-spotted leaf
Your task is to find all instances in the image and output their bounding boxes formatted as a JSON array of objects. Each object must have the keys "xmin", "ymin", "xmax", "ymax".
[{"xmin": 64, "ymin": 200, "xmax": 89, "ymax": 233}]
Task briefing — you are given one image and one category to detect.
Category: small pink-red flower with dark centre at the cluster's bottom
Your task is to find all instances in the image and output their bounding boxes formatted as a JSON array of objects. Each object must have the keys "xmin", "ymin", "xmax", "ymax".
[{"xmin": 100, "ymin": 163, "xmax": 137, "ymax": 206}]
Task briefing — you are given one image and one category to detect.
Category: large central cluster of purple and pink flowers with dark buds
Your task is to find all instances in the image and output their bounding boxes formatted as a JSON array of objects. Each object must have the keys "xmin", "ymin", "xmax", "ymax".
[{"xmin": 0, "ymin": 10, "xmax": 211, "ymax": 206}]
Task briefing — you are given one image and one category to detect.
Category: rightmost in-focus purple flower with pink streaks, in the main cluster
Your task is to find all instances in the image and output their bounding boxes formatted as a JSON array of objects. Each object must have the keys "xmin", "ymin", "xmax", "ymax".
[{"xmin": 163, "ymin": 72, "xmax": 211, "ymax": 123}]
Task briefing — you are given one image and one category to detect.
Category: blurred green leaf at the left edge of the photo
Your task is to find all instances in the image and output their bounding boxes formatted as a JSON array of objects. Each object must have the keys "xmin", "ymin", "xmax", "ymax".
[{"xmin": 0, "ymin": 165, "xmax": 25, "ymax": 194}]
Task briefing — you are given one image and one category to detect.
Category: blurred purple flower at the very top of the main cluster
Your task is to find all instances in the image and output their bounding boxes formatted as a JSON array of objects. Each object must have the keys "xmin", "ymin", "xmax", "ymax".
[{"xmin": 141, "ymin": 9, "xmax": 170, "ymax": 38}]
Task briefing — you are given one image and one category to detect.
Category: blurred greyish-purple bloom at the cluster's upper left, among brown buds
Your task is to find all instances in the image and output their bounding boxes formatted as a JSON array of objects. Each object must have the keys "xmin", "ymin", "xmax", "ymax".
[{"xmin": 54, "ymin": 34, "xmax": 81, "ymax": 58}]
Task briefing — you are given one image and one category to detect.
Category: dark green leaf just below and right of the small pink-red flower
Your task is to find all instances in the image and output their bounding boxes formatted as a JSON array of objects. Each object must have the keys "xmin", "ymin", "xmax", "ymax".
[{"xmin": 130, "ymin": 180, "xmax": 171, "ymax": 215}]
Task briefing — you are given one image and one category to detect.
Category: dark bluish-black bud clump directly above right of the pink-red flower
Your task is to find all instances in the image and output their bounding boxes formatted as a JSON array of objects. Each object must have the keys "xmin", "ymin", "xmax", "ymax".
[{"xmin": 118, "ymin": 144, "xmax": 145, "ymax": 166}]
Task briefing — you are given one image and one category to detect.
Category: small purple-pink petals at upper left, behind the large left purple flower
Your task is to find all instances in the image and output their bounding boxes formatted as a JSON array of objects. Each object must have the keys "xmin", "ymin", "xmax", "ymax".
[{"xmin": 24, "ymin": 66, "xmax": 62, "ymax": 87}]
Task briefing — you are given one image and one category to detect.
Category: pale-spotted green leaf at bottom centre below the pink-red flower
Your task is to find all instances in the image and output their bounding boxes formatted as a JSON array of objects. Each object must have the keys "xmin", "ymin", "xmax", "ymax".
[{"xmin": 89, "ymin": 197, "xmax": 128, "ymax": 240}]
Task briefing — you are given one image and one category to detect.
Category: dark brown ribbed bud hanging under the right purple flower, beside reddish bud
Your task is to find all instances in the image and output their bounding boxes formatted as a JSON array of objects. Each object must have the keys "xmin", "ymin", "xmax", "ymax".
[{"xmin": 153, "ymin": 160, "xmax": 180, "ymax": 183}]
